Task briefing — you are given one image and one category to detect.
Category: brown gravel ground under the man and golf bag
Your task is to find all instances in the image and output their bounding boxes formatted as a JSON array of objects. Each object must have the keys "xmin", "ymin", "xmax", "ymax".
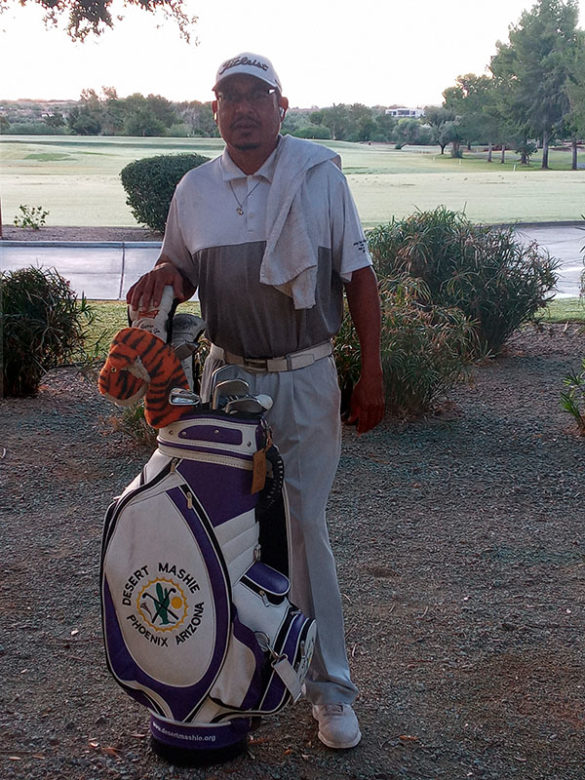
[{"xmin": 0, "ymin": 326, "xmax": 585, "ymax": 780}]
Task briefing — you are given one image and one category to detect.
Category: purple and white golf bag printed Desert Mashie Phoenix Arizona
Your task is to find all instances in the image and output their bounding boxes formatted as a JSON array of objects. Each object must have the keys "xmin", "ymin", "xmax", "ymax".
[{"xmin": 101, "ymin": 394, "xmax": 316, "ymax": 760}]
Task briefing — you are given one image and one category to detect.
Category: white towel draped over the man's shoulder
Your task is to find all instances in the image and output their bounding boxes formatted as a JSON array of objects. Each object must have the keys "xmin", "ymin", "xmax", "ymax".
[{"xmin": 260, "ymin": 135, "xmax": 341, "ymax": 309}]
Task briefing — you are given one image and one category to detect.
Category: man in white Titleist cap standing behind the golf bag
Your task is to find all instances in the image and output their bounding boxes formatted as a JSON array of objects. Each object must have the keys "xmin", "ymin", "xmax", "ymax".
[{"xmin": 127, "ymin": 53, "xmax": 384, "ymax": 748}]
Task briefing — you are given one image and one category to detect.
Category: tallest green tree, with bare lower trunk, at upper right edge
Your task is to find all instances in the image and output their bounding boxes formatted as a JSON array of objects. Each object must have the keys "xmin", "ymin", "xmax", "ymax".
[{"xmin": 490, "ymin": 0, "xmax": 580, "ymax": 169}]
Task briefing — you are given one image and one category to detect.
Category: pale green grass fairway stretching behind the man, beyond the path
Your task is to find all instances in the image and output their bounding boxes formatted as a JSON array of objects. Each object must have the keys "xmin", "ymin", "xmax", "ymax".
[{"xmin": 0, "ymin": 136, "xmax": 585, "ymax": 227}]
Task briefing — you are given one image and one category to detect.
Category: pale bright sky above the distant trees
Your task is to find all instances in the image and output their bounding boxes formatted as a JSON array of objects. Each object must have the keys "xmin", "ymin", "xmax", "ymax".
[{"xmin": 0, "ymin": 0, "xmax": 585, "ymax": 108}]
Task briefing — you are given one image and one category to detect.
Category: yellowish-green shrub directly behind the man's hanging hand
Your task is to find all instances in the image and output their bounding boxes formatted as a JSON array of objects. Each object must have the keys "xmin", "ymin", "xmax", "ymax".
[{"xmin": 334, "ymin": 276, "xmax": 474, "ymax": 417}]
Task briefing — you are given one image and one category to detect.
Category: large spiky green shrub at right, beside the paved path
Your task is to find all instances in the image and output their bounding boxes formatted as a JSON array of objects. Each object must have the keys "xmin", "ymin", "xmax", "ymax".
[{"xmin": 368, "ymin": 207, "xmax": 558, "ymax": 354}]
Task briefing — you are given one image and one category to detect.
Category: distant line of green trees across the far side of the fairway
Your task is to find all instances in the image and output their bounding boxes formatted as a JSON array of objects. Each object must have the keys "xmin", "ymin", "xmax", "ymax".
[{"xmin": 0, "ymin": 0, "xmax": 585, "ymax": 168}]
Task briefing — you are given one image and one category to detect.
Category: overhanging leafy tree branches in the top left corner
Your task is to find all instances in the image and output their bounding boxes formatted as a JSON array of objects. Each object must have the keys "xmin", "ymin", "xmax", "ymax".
[{"xmin": 0, "ymin": 0, "xmax": 197, "ymax": 43}]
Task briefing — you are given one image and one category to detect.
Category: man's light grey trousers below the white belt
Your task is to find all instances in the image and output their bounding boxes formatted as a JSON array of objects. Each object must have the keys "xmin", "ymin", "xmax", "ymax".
[{"xmin": 201, "ymin": 357, "xmax": 357, "ymax": 704}]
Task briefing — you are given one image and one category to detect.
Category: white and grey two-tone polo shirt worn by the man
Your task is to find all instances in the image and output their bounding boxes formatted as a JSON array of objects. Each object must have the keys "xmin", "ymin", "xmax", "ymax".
[{"xmin": 162, "ymin": 142, "xmax": 371, "ymax": 358}]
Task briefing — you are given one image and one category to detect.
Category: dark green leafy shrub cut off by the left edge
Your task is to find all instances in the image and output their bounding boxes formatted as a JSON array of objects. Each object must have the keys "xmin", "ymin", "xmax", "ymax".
[{"xmin": 0, "ymin": 267, "xmax": 93, "ymax": 397}]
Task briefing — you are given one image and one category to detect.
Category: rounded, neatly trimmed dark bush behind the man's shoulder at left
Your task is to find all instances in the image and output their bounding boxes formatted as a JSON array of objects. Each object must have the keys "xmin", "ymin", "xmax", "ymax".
[{"xmin": 120, "ymin": 154, "xmax": 209, "ymax": 233}]
